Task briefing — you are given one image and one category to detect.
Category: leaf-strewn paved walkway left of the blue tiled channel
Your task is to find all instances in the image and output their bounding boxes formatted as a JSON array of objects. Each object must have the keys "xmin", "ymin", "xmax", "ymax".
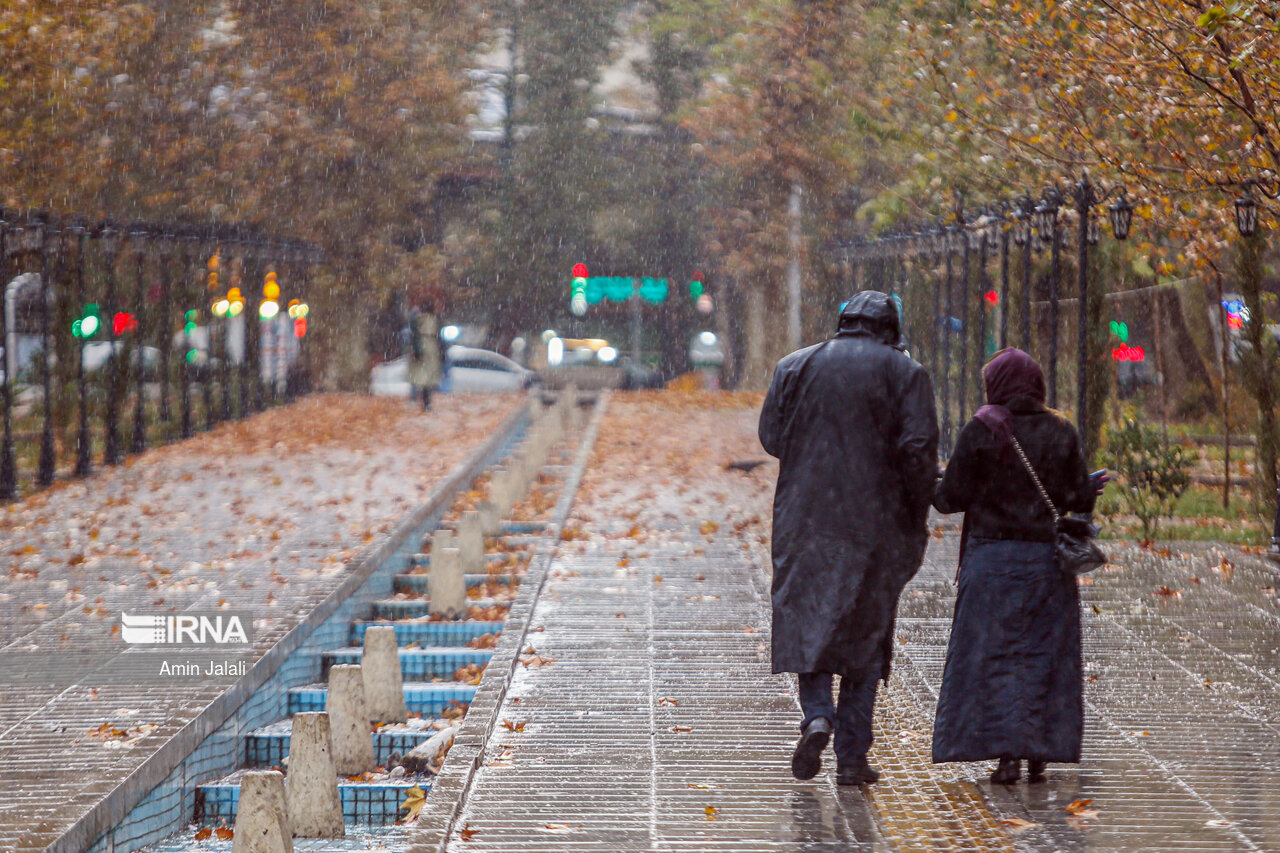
[{"xmin": 0, "ymin": 394, "xmax": 520, "ymax": 850}]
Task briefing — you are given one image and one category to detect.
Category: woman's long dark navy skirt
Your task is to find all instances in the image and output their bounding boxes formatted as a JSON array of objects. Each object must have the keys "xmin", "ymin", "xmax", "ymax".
[{"xmin": 933, "ymin": 539, "xmax": 1084, "ymax": 762}]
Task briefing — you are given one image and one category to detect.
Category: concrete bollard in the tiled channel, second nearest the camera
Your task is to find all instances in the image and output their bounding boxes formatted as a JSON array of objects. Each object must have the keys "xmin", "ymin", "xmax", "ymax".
[{"xmin": 284, "ymin": 711, "xmax": 347, "ymax": 838}]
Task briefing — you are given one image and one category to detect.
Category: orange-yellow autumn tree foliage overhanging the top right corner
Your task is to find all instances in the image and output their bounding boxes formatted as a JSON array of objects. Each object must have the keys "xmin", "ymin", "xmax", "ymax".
[{"xmin": 904, "ymin": 0, "xmax": 1280, "ymax": 504}]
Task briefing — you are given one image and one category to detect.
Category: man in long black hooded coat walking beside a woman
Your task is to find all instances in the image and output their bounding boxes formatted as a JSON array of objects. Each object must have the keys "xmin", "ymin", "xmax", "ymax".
[{"xmin": 760, "ymin": 291, "xmax": 938, "ymax": 785}]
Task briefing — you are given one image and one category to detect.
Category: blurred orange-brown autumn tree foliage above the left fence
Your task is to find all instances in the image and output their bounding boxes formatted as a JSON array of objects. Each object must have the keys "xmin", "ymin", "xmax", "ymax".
[{"xmin": 0, "ymin": 0, "xmax": 483, "ymax": 384}]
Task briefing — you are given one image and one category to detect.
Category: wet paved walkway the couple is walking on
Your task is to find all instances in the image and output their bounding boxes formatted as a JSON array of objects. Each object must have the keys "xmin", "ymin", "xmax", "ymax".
[{"xmin": 430, "ymin": 394, "xmax": 1280, "ymax": 852}]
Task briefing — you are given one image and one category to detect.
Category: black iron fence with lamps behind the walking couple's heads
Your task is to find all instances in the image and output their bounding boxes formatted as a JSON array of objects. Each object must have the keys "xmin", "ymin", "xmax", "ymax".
[{"xmin": 836, "ymin": 175, "xmax": 1133, "ymax": 452}]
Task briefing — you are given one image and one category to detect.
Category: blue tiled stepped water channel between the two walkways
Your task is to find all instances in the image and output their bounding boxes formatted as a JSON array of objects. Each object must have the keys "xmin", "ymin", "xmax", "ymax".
[{"xmin": 82, "ymin": 407, "xmax": 558, "ymax": 853}]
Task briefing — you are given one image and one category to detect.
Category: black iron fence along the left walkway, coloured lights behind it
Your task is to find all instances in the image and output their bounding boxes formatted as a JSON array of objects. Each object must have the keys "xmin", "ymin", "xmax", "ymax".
[{"xmin": 0, "ymin": 209, "xmax": 324, "ymax": 501}]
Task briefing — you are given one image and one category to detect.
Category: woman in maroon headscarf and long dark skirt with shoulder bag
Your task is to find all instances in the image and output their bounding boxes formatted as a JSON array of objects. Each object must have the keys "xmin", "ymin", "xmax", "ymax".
[{"xmin": 933, "ymin": 350, "xmax": 1098, "ymax": 784}]
